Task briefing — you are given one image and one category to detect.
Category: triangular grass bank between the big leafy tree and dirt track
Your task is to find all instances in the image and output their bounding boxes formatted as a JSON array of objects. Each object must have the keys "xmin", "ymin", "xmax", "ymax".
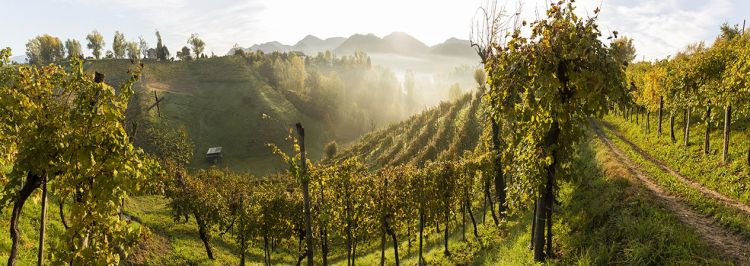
[{"xmin": 557, "ymin": 135, "xmax": 731, "ymax": 265}]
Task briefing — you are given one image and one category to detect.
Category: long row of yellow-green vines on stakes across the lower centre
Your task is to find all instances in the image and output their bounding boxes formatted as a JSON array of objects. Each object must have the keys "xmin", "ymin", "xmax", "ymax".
[{"xmin": 165, "ymin": 132, "xmax": 495, "ymax": 265}]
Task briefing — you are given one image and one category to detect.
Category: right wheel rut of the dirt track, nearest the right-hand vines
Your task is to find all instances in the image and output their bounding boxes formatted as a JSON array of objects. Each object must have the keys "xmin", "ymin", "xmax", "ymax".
[{"xmin": 602, "ymin": 122, "xmax": 750, "ymax": 216}]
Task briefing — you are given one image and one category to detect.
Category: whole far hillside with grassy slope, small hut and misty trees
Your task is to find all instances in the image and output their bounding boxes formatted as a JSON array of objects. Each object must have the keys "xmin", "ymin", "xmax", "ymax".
[{"xmin": 86, "ymin": 56, "xmax": 412, "ymax": 174}]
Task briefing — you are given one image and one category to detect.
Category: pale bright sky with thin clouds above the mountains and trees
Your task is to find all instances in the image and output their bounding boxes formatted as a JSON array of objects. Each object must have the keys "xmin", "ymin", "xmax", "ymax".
[{"xmin": 0, "ymin": 0, "xmax": 750, "ymax": 60}]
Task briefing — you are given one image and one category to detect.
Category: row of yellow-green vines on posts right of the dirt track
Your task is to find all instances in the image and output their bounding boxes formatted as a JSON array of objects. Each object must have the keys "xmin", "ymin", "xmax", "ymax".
[{"xmin": 619, "ymin": 24, "xmax": 750, "ymax": 164}]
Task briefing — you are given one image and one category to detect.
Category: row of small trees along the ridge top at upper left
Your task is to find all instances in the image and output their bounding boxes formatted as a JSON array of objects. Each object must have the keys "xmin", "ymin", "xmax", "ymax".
[{"xmin": 26, "ymin": 30, "xmax": 206, "ymax": 65}]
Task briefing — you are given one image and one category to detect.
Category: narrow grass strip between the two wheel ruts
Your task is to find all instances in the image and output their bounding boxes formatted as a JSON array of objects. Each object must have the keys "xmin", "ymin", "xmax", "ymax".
[{"xmin": 603, "ymin": 117, "xmax": 750, "ymax": 237}]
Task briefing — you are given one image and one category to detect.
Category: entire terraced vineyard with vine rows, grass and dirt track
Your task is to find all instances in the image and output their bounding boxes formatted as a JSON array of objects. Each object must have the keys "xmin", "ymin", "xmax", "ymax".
[{"xmin": 0, "ymin": 0, "xmax": 750, "ymax": 265}]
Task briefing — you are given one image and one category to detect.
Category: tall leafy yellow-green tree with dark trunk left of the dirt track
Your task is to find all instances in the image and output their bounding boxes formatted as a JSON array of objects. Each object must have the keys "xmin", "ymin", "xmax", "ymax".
[{"xmin": 485, "ymin": 0, "xmax": 625, "ymax": 261}]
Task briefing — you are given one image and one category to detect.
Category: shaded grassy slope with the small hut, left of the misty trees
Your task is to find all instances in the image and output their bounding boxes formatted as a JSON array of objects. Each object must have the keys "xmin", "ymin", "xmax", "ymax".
[{"xmin": 86, "ymin": 56, "xmax": 340, "ymax": 174}]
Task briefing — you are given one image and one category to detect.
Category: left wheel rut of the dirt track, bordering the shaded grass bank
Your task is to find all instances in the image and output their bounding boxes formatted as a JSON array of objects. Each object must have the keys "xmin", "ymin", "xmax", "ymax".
[{"xmin": 593, "ymin": 123, "xmax": 750, "ymax": 265}]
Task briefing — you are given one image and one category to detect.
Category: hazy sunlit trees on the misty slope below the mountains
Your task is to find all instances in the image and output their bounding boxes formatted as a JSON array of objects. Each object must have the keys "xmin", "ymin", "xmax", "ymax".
[{"xmin": 234, "ymin": 48, "xmax": 417, "ymax": 140}]
